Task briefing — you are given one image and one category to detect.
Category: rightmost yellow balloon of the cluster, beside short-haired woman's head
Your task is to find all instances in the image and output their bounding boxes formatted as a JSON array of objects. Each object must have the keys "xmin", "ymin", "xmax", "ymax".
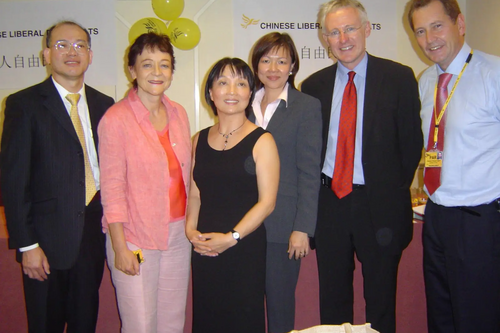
[{"xmin": 167, "ymin": 18, "xmax": 201, "ymax": 50}]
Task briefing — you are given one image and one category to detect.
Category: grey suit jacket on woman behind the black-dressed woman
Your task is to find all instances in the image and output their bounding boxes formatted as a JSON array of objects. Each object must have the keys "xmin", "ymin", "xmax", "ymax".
[{"xmin": 249, "ymin": 87, "xmax": 322, "ymax": 244}]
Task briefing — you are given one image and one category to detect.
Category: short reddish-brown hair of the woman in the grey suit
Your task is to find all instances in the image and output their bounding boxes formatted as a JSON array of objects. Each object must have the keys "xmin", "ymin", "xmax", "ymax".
[{"xmin": 252, "ymin": 32, "xmax": 299, "ymax": 89}]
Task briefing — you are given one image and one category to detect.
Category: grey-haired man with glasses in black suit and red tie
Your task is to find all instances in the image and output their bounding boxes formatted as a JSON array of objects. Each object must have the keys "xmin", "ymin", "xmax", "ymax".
[{"xmin": 302, "ymin": 0, "xmax": 422, "ymax": 333}]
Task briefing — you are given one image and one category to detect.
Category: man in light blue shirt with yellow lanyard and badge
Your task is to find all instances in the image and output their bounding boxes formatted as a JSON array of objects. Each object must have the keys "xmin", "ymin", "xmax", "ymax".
[{"xmin": 408, "ymin": 0, "xmax": 500, "ymax": 333}]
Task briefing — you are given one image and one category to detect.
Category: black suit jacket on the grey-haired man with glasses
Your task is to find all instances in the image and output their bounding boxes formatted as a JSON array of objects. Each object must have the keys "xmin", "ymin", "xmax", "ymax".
[{"xmin": 302, "ymin": 55, "xmax": 423, "ymax": 253}]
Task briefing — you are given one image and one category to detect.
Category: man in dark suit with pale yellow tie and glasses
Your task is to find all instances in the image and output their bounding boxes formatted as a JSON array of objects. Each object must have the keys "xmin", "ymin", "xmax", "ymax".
[{"xmin": 0, "ymin": 21, "xmax": 113, "ymax": 333}]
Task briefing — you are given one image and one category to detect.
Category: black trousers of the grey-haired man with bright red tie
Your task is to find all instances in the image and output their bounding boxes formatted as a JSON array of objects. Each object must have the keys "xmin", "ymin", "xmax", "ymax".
[{"xmin": 315, "ymin": 187, "xmax": 401, "ymax": 333}]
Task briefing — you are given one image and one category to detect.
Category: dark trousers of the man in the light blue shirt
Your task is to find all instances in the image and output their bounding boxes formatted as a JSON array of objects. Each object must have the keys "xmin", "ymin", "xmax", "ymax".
[{"xmin": 422, "ymin": 200, "xmax": 500, "ymax": 333}]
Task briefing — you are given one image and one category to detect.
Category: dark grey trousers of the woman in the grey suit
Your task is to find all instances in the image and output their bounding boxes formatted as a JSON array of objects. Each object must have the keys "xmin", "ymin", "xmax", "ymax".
[{"xmin": 266, "ymin": 242, "xmax": 300, "ymax": 333}]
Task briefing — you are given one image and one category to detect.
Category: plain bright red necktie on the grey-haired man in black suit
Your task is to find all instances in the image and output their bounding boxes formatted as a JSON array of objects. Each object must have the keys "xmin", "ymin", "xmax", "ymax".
[{"xmin": 332, "ymin": 71, "xmax": 358, "ymax": 199}]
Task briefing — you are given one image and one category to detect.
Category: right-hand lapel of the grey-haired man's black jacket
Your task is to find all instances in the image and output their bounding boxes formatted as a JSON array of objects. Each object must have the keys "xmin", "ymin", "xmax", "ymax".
[{"xmin": 362, "ymin": 54, "xmax": 384, "ymax": 150}]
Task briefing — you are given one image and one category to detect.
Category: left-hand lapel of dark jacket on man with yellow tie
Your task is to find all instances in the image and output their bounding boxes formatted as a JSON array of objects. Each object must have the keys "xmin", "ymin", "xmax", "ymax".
[{"xmin": 42, "ymin": 77, "xmax": 80, "ymax": 142}]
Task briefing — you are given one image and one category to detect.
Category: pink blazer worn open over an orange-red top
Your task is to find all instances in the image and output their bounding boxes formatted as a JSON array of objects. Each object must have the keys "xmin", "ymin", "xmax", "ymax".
[{"xmin": 98, "ymin": 89, "xmax": 191, "ymax": 250}]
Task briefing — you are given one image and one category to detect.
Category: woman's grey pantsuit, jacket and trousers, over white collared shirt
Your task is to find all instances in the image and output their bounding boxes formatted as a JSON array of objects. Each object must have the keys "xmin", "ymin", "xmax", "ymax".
[{"xmin": 249, "ymin": 86, "xmax": 322, "ymax": 333}]
